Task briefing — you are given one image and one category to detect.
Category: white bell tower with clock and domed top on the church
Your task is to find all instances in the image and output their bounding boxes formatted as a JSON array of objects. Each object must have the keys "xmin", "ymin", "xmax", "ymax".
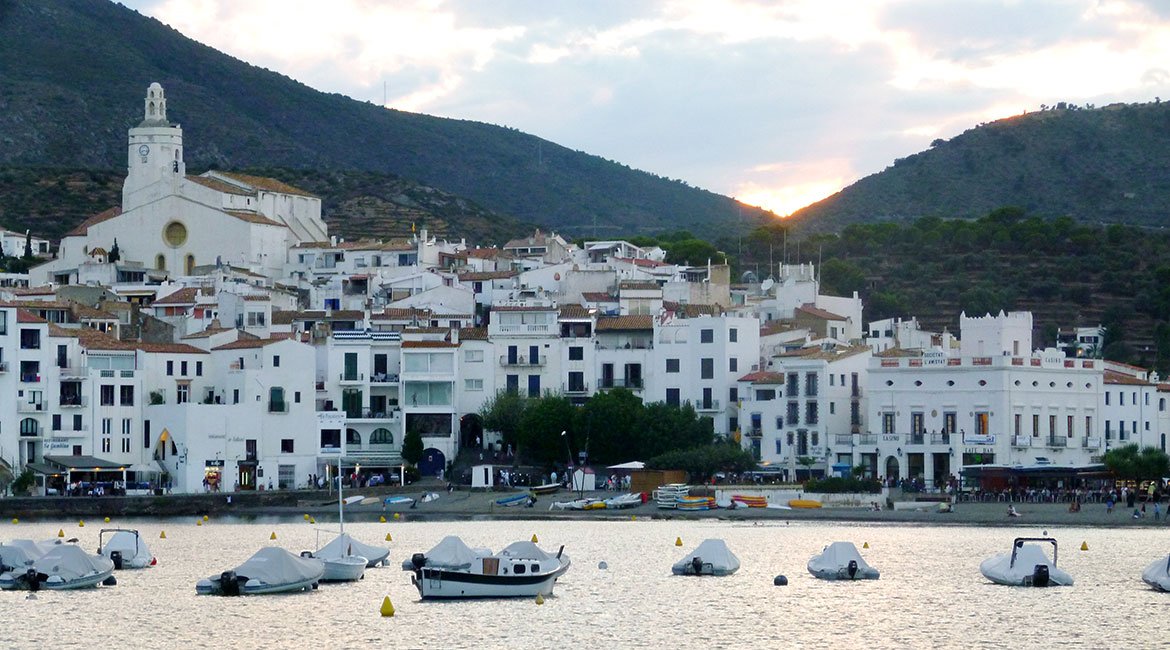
[{"xmin": 122, "ymin": 82, "xmax": 187, "ymax": 212}]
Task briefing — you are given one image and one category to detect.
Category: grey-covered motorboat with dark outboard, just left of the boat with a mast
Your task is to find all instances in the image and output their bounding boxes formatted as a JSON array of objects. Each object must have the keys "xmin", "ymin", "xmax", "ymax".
[{"xmin": 195, "ymin": 546, "xmax": 325, "ymax": 596}]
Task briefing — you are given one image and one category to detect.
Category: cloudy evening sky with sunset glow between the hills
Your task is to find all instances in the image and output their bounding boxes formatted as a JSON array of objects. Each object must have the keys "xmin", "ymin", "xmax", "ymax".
[{"xmin": 123, "ymin": 0, "xmax": 1170, "ymax": 214}]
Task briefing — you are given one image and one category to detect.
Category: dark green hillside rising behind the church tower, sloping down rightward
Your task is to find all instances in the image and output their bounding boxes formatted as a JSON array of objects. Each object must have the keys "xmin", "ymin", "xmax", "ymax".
[{"xmin": 0, "ymin": 0, "xmax": 769, "ymax": 236}]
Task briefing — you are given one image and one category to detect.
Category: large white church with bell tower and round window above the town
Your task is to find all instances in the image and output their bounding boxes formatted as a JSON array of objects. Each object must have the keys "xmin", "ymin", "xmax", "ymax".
[{"xmin": 30, "ymin": 83, "xmax": 329, "ymax": 285}]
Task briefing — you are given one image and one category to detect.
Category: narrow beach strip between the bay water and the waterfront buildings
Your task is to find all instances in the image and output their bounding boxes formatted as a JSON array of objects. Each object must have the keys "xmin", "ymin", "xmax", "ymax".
[{"xmin": 276, "ymin": 490, "xmax": 1170, "ymax": 527}]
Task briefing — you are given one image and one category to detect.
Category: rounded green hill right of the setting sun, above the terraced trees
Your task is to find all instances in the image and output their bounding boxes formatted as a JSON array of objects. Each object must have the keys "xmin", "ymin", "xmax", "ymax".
[{"xmin": 791, "ymin": 102, "xmax": 1170, "ymax": 231}]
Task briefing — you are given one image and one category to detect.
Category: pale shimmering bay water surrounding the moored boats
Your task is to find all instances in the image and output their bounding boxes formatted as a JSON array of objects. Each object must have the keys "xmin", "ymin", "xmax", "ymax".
[{"xmin": 0, "ymin": 519, "xmax": 1170, "ymax": 649}]
